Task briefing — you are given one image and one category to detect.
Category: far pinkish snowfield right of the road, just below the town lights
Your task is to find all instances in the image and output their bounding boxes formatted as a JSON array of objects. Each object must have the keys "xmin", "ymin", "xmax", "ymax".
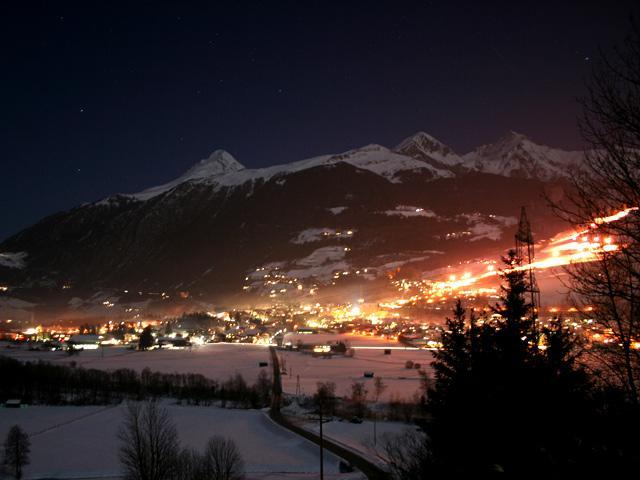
[{"xmin": 278, "ymin": 334, "xmax": 433, "ymax": 402}]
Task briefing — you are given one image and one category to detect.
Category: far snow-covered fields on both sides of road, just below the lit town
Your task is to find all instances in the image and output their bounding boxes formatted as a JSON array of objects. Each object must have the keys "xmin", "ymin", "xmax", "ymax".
[{"xmin": 0, "ymin": 334, "xmax": 432, "ymax": 402}]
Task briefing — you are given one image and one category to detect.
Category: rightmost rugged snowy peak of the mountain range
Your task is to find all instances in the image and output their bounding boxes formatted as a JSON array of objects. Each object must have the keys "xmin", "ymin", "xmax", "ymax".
[{"xmin": 462, "ymin": 132, "xmax": 584, "ymax": 181}]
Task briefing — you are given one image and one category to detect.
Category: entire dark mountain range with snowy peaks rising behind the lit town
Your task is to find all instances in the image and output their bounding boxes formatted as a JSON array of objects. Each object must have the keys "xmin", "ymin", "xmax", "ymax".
[{"xmin": 0, "ymin": 132, "xmax": 583, "ymax": 314}]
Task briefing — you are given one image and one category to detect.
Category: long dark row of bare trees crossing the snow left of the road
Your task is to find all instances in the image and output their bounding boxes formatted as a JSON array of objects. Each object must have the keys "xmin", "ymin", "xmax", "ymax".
[{"xmin": 0, "ymin": 356, "xmax": 272, "ymax": 408}]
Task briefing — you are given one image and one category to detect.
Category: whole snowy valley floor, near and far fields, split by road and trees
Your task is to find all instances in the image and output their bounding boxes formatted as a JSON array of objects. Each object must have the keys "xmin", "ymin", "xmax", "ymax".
[{"xmin": 0, "ymin": 335, "xmax": 432, "ymax": 480}]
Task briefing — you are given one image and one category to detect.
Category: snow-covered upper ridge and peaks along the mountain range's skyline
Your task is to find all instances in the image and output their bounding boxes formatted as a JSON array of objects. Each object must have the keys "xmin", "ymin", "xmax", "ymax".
[{"xmin": 116, "ymin": 132, "xmax": 582, "ymax": 203}]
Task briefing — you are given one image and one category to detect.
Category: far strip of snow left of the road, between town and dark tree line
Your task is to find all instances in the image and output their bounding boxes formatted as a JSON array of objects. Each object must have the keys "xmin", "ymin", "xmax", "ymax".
[{"xmin": 0, "ymin": 343, "xmax": 271, "ymax": 384}]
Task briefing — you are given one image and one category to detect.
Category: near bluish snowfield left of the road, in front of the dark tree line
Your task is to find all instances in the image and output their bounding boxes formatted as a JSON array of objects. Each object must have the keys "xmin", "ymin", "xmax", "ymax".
[{"xmin": 0, "ymin": 405, "xmax": 361, "ymax": 479}]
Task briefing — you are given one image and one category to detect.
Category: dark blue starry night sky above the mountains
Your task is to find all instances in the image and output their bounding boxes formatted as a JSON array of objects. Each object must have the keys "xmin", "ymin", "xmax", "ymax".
[{"xmin": 0, "ymin": 0, "xmax": 637, "ymax": 239}]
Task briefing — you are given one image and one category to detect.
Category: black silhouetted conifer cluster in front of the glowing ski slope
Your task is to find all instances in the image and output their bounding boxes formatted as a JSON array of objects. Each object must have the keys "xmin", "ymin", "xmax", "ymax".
[{"xmin": 423, "ymin": 251, "xmax": 594, "ymax": 475}]
